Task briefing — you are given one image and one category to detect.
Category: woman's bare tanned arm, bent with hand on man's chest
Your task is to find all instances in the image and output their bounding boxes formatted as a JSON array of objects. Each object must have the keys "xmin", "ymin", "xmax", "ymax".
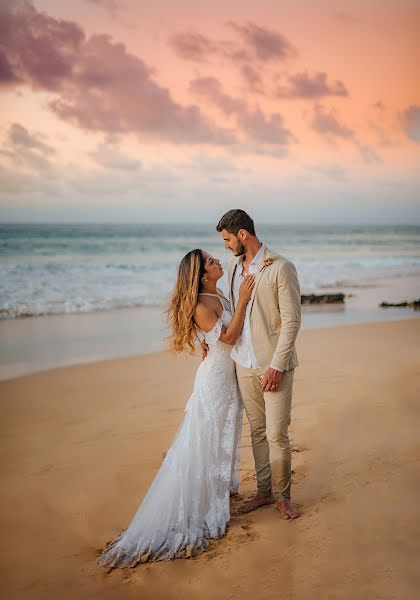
[{"xmin": 194, "ymin": 275, "xmax": 255, "ymax": 346}]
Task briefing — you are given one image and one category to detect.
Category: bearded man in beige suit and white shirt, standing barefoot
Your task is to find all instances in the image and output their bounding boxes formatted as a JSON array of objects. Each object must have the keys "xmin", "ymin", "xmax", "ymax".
[{"xmin": 216, "ymin": 209, "xmax": 301, "ymax": 519}]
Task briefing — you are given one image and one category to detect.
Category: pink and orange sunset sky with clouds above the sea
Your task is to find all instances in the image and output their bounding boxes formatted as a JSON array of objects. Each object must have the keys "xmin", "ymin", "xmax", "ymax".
[{"xmin": 0, "ymin": 0, "xmax": 420, "ymax": 224}]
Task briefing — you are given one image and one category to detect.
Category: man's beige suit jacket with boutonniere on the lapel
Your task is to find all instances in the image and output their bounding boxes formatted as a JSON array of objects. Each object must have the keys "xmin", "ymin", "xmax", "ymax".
[{"xmin": 228, "ymin": 248, "xmax": 301, "ymax": 371}]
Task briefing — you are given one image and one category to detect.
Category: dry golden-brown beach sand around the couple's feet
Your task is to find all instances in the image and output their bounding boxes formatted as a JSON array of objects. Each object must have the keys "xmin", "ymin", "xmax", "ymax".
[{"xmin": 0, "ymin": 319, "xmax": 420, "ymax": 600}]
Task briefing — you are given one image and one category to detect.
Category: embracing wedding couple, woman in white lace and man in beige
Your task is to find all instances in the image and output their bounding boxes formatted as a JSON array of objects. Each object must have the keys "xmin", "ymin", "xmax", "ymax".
[{"xmin": 97, "ymin": 209, "xmax": 301, "ymax": 569}]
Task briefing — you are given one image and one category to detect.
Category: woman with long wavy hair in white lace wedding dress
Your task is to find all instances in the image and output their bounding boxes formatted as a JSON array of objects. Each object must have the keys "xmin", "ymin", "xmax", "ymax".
[{"xmin": 96, "ymin": 250, "xmax": 254, "ymax": 570}]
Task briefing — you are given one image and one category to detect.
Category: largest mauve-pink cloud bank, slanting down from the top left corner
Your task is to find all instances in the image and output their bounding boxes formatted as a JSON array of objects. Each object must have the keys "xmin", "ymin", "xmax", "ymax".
[{"xmin": 0, "ymin": 0, "xmax": 234, "ymax": 144}]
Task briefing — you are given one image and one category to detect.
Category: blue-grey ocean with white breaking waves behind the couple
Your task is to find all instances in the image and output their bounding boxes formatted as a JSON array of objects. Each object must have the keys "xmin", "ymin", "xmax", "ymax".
[{"xmin": 0, "ymin": 224, "xmax": 420, "ymax": 319}]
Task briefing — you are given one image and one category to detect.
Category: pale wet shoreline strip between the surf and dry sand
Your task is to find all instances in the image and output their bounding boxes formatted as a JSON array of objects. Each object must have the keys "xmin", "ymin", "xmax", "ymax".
[{"xmin": 0, "ymin": 277, "xmax": 420, "ymax": 380}]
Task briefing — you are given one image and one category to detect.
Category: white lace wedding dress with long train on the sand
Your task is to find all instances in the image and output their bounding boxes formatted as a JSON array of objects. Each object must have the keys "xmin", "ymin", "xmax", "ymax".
[{"xmin": 96, "ymin": 298, "xmax": 242, "ymax": 569}]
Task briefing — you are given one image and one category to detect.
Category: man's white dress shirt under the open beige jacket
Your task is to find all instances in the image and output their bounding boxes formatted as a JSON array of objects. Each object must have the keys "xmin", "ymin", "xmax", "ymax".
[{"xmin": 230, "ymin": 244, "xmax": 280, "ymax": 371}]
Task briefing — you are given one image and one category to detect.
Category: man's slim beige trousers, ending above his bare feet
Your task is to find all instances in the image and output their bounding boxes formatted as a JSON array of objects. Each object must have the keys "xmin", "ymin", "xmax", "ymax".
[{"xmin": 236, "ymin": 364, "xmax": 294, "ymax": 502}]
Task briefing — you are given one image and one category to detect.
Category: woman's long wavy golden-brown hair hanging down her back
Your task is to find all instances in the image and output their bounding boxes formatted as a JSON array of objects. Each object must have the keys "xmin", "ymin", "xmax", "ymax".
[{"xmin": 165, "ymin": 249, "xmax": 206, "ymax": 354}]
